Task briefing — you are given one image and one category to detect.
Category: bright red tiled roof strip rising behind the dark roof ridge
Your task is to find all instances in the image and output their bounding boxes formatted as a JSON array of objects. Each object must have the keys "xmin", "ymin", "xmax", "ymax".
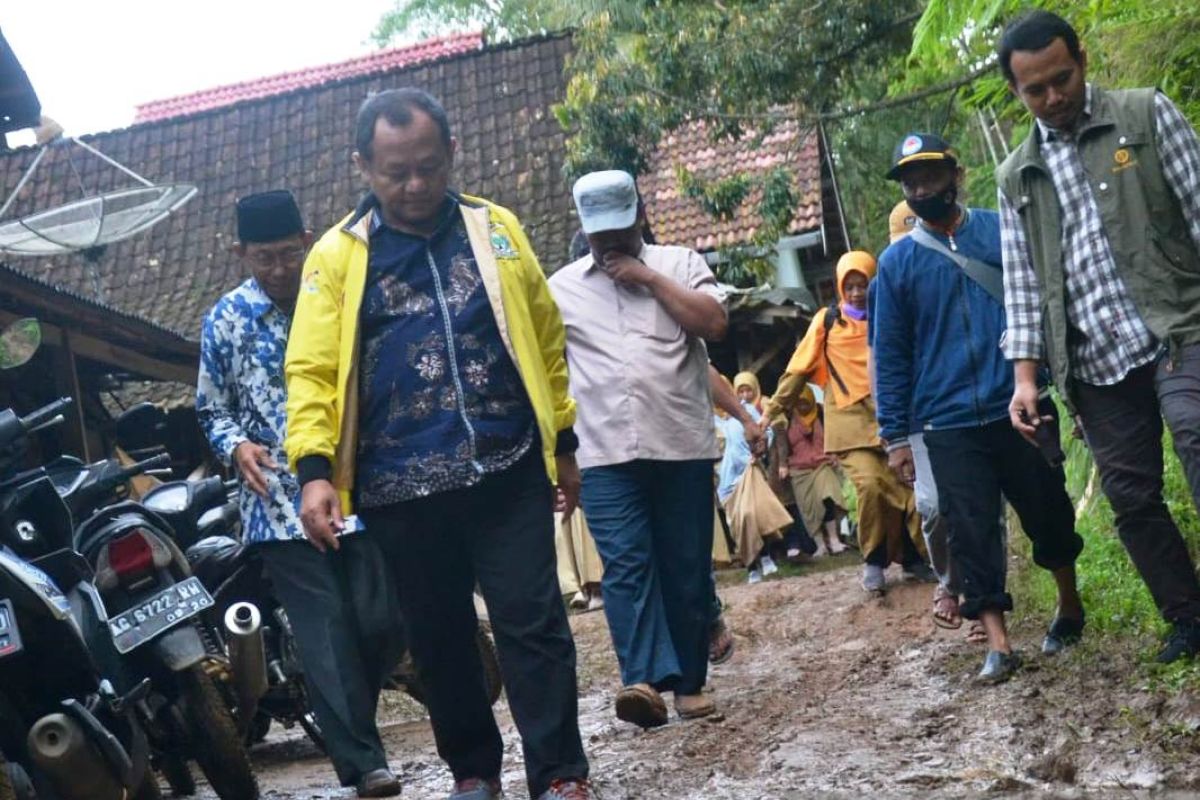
[{"xmin": 133, "ymin": 31, "xmax": 484, "ymax": 124}]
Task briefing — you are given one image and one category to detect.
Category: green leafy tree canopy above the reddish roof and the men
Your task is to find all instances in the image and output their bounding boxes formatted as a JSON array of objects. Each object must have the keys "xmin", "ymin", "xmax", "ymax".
[{"xmin": 376, "ymin": 0, "xmax": 1200, "ymax": 269}]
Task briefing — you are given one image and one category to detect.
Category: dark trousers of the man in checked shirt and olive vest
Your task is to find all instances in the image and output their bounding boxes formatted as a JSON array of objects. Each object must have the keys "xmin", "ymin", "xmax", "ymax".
[{"xmin": 1074, "ymin": 347, "xmax": 1200, "ymax": 622}]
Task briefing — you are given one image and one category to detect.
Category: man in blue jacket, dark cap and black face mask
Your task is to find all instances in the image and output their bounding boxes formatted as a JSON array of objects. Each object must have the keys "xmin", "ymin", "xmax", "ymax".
[{"xmin": 872, "ymin": 133, "xmax": 1084, "ymax": 682}]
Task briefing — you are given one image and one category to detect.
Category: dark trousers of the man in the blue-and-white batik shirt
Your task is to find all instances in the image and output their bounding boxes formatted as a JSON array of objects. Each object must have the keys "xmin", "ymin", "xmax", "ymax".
[{"xmin": 254, "ymin": 535, "xmax": 402, "ymax": 786}]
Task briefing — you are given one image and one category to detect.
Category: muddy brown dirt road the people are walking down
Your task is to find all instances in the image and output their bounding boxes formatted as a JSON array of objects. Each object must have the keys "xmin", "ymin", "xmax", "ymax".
[{"xmin": 192, "ymin": 561, "xmax": 1200, "ymax": 800}]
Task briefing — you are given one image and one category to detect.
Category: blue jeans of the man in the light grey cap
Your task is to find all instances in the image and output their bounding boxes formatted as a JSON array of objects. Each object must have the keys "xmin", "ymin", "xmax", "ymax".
[{"xmin": 582, "ymin": 461, "xmax": 713, "ymax": 694}]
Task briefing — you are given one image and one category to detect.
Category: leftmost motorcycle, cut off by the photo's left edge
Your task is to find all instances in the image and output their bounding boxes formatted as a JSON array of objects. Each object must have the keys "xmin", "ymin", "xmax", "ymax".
[{"xmin": 0, "ymin": 391, "xmax": 160, "ymax": 800}]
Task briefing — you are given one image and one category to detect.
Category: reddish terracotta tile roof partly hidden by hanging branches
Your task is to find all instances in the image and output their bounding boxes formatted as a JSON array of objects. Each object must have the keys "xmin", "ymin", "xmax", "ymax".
[{"xmin": 638, "ymin": 124, "xmax": 821, "ymax": 252}]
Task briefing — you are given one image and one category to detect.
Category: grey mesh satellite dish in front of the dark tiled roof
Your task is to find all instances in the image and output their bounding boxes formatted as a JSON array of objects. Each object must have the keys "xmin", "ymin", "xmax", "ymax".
[{"xmin": 0, "ymin": 138, "xmax": 198, "ymax": 255}]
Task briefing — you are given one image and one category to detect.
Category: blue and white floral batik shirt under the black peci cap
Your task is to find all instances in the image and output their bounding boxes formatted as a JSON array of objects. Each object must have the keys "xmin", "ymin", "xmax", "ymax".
[{"xmin": 196, "ymin": 278, "xmax": 305, "ymax": 543}]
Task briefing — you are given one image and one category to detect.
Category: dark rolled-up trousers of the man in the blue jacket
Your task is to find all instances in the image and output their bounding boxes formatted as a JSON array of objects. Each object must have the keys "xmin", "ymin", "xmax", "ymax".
[{"xmin": 925, "ymin": 412, "xmax": 1084, "ymax": 619}]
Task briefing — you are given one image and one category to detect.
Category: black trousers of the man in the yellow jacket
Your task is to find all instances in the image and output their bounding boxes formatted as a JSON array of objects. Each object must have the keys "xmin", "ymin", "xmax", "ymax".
[{"xmin": 360, "ymin": 453, "xmax": 588, "ymax": 798}]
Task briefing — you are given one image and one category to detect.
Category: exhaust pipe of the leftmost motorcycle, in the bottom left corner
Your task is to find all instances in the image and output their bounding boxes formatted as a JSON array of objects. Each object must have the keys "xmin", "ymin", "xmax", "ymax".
[{"xmin": 26, "ymin": 714, "xmax": 126, "ymax": 800}]
